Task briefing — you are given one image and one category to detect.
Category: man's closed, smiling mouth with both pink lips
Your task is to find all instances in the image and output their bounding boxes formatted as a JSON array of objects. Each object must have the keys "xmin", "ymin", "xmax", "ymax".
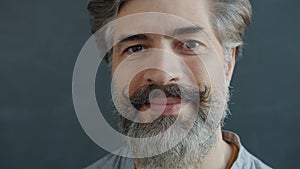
[{"xmin": 142, "ymin": 97, "xmax": 186, "ymax": 116}]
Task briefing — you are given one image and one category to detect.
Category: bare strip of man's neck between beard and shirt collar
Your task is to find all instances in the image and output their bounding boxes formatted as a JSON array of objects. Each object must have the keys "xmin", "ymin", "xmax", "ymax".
[{"xmin": 135, "ymin": 127, "xmax": 232, "ymax": 169}]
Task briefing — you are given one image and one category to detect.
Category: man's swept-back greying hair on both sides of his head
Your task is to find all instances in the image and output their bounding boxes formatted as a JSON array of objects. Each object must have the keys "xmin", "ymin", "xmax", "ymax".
[{"xmin": 88, "ymin": 0, "xmax": 252, "ymax": 62}]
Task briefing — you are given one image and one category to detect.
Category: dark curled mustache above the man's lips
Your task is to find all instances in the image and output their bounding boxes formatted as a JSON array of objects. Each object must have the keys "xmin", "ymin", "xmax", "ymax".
[{"xmin": 129, "ymin": 84, "xmax": 210, "ymax": 110}]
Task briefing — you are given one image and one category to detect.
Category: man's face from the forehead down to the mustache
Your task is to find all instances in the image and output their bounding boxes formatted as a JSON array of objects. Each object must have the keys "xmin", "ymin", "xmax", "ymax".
[{"xmin": 112, "ymin": 0, "xmax": 228, "ymax": 115}]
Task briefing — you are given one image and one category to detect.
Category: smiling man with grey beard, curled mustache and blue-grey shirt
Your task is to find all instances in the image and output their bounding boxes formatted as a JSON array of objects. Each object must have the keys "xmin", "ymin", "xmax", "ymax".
[{"xmin": 88, "ymin": 0, "xmax": 270, "ymax": 169}]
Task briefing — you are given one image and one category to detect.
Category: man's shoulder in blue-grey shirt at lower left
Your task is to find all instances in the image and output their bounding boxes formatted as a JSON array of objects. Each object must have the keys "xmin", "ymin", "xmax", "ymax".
[{"xmin": 85, "ymin": 154, "xmax": 134, "ymax": 169}]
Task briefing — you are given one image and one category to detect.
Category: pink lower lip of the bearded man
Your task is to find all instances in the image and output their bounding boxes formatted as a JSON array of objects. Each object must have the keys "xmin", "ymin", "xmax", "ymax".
[{"xmin": 147, "ymin": 103, "xmax": 183, "ymax": 115}]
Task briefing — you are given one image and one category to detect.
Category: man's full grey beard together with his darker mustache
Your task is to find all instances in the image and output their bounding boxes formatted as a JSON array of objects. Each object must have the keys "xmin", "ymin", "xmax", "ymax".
[{"xmin": 113, "ymin": 84, "xmax": 229, "ymax": 169}]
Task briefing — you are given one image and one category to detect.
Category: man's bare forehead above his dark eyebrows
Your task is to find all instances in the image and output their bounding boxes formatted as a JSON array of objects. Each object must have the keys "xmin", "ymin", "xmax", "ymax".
[{"xmin": 115, "ymin": 0, "xmax": 213, "ymax": 39}]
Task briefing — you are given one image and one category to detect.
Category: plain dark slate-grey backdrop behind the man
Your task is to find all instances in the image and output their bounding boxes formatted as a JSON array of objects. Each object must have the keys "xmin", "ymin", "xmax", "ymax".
[{"xmin": 0, "ymin": 0, "xmax": 300, "ymax": 169}]
